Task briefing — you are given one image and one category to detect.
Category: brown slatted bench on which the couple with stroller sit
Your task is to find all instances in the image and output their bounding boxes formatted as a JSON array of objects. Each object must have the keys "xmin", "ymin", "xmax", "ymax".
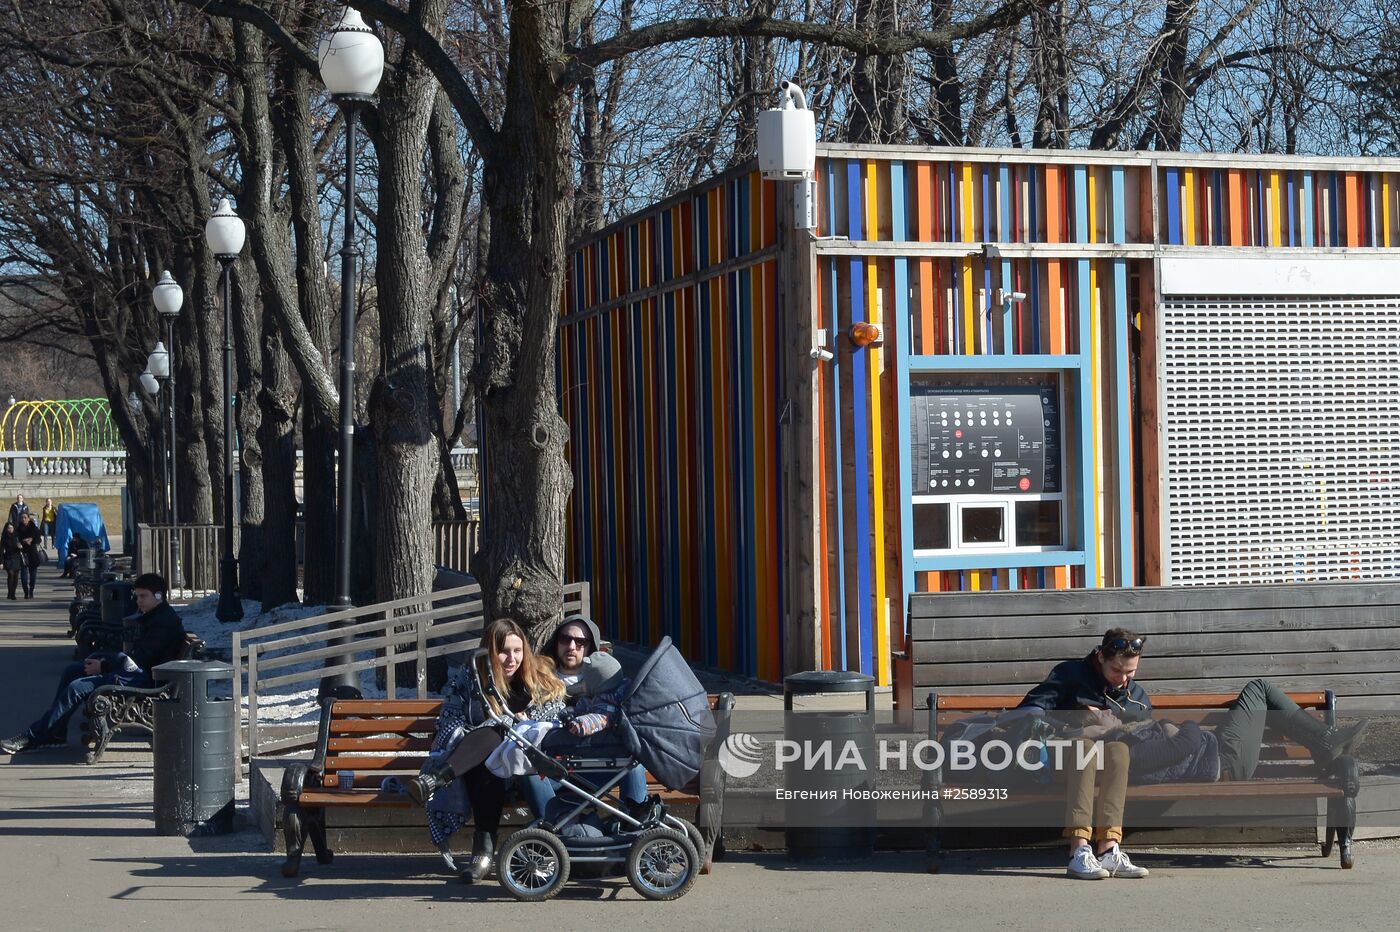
[{"xmin": 281, "ymin": 693, "xmax": 734, "ymax": 877}]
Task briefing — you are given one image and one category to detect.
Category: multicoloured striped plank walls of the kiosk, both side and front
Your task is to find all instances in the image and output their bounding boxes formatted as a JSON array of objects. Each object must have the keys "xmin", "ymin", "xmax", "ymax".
[{"xmin": 559, "ymin": 146, "xmax": 1400, "ymax": 683}]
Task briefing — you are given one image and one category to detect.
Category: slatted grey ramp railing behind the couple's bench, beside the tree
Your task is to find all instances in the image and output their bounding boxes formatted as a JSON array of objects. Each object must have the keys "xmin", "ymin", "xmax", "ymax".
[{"xmin": 231, "ymin": 582, "xmax": 591, "ymax": 778}]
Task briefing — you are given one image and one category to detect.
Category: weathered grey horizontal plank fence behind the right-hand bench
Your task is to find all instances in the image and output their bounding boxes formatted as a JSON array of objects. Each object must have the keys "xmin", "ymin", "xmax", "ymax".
[{"xmin": 900, "ymin": 582, "xmax": 1400, "ymax": 709}]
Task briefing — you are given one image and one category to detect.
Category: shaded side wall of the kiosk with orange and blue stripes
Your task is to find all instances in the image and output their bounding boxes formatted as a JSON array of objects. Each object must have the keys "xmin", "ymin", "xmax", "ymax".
[{"xmin": 559, "ymin": 165, "xmax": 783, "ymax": 680}]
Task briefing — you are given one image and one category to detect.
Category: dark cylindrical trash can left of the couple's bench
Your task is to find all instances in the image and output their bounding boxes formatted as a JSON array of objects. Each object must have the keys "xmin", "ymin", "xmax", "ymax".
[{"xmin": 151, "ymin": 661, "xmax": 235, "ymax": 837}]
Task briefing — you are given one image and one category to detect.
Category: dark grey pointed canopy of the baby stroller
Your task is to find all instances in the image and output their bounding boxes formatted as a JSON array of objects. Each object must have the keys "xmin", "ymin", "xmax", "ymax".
[{"xmin": 617, "ymin": 638, "xmax": 715, "ymax": 789}]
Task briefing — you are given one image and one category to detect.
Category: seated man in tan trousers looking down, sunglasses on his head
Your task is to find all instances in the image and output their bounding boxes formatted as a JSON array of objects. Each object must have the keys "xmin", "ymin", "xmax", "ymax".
[{"xmin": 1021, "ymin": 628, "xmax": 1152, "ymax": 880}]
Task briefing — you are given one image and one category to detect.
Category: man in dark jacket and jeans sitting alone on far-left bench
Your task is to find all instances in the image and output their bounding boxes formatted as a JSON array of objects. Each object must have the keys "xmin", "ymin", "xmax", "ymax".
[{"xmin": 0, "ymin": 572, "xmax": 185, "ymax": 754}]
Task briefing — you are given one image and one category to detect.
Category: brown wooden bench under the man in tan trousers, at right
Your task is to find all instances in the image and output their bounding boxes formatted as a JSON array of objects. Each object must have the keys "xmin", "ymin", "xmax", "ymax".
[{"xmin": 925, "ymin": 691, "xmax": 1359, "ymax": 873}]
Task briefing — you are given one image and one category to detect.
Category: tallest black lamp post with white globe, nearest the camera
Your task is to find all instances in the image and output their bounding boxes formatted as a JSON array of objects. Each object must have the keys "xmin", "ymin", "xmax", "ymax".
[{"xmin": 319, "ymin": 7, "xmax": 384, "ymax": 694}]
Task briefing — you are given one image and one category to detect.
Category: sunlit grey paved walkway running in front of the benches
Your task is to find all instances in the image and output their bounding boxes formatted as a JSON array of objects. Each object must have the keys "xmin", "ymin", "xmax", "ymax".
[{"xmin": 0, "ymin": 568, "xmax": 1400, "ymax": 932}]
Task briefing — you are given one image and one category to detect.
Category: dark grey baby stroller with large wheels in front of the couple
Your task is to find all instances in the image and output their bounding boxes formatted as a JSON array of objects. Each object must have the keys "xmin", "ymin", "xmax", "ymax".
[{"xmin": 472, "ymin": 638, "xmax": 715, "ymax": 901}]
